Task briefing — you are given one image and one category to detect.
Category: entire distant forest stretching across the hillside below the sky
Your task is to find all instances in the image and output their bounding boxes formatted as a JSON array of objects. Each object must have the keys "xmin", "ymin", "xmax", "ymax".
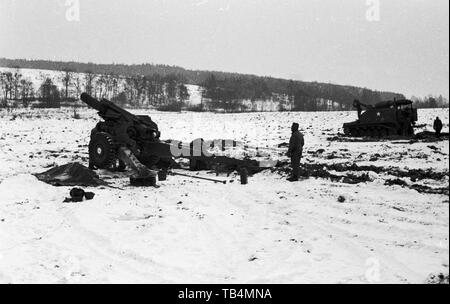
[{"xmin": 0, "ymin": 58, "xmax": 448, "ymax": 112}]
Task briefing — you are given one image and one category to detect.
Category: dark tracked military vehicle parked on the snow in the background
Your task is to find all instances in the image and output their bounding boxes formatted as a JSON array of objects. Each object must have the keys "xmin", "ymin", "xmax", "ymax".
[{"xmin": 343, "ymin": 99, "xmax": 417, "ymax": 138}]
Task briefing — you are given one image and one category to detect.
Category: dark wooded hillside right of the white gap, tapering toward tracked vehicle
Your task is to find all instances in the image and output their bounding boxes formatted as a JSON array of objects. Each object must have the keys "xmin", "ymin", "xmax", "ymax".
[{"xmin": 200, "ymin": 73, "xmax": 405, "ymax": 111}]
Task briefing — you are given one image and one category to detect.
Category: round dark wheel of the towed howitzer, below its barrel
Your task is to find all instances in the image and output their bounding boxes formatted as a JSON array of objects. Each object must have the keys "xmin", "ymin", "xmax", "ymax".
[{"xmin": 89, "ymin": 132, "xmax": 117, "ymax": 169}]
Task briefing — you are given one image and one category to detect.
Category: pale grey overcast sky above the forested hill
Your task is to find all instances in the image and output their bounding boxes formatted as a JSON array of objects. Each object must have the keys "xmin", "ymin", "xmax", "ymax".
[{"xmin": 0, "ymin": 0, "xmax": 449, "ymax": 97}]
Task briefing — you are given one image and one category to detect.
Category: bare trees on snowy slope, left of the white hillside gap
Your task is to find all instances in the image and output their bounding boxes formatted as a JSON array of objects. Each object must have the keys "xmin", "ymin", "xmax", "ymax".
[{"xmin": 0, "ymin": 67, "xmax": 189, "ymax": 110}]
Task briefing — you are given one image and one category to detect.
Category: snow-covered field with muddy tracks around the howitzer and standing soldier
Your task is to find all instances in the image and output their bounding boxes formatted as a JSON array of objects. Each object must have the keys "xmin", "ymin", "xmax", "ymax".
[{"xmin": 0, "ymin": 109, "xmax": 449, "ymax": 283}]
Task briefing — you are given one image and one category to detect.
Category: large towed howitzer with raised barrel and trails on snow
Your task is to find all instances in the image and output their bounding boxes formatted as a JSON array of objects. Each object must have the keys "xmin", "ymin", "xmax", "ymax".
[{"xmin": 81, "ymin": 93, "xmax": 274, "ymax": 182}]
